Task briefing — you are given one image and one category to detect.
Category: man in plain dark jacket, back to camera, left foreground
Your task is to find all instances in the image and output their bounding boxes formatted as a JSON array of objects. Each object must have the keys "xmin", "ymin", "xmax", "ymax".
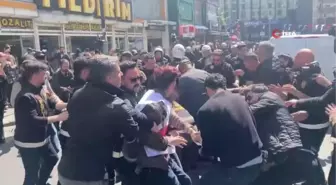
[{"xmin": 58, "ymin": 58, "xmax": 138, "ymax": 185}]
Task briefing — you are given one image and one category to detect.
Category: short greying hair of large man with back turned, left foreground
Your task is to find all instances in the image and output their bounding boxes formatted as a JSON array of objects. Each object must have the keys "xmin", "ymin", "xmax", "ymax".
[{"xmin": 88, "ymin": 58, "xmax": 119, "ymax": 84}]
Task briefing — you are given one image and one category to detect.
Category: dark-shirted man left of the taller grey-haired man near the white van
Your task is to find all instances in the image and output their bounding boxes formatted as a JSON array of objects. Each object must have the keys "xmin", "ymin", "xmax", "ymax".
[{"xmin": 204, "ymin": 49, "xmax": 236, "ymax": 88}]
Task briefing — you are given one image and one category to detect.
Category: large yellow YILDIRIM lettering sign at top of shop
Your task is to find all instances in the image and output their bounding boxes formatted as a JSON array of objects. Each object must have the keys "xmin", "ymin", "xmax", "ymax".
[{"xmin": 35, "ymin": 0, "xmax": 132, "ymax": 22}]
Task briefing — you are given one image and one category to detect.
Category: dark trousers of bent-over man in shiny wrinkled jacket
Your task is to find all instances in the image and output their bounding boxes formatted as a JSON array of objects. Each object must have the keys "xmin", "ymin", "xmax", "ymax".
[{"xmin": 252, "ymin": 148, "xmax": 326, "ymax": 185}]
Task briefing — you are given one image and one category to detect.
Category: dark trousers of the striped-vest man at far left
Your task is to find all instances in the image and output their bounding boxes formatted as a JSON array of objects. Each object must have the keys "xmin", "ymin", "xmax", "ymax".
[{"xmin": 17, "ymin": 144, "xmax": 58, "ymax": 185}]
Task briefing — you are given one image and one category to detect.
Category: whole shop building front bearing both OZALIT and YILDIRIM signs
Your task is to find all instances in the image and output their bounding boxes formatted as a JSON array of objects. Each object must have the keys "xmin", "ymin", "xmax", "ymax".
[{"xmin": 0, "ymin": 0, "xmax": 147, "ymax": 55}]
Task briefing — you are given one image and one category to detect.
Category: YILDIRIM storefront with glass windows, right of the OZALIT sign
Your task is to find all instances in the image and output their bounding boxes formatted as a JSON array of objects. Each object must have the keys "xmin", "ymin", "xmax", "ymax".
[{"xmin": 34, "ymin": 0, "xmax": 147, "ymax": 54}]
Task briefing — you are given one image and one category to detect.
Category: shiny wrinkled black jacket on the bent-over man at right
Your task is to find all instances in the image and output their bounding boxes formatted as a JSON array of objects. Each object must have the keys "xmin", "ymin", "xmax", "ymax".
[{"xmin": 250, "ymin": 92, "xmax": 302, "ymax": 160}]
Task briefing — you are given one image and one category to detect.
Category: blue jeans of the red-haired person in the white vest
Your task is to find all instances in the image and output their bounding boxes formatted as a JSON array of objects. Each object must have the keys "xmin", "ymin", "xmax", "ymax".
[{"xmin": 140, "ymin": 159, "xmax": 192, "ymax": 185}]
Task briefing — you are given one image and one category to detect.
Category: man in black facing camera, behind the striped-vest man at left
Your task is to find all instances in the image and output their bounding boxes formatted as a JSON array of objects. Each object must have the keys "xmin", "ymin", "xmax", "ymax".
[{"xmin": 51, "ymin": 59, "xmax": 73, "ymax": 102}]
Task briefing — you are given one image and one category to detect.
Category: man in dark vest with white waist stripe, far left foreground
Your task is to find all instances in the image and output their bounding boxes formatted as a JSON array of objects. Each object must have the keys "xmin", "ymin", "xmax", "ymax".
[{"xmin": 14, "ymin": 60, "xmax": 68, "ymax": 185}]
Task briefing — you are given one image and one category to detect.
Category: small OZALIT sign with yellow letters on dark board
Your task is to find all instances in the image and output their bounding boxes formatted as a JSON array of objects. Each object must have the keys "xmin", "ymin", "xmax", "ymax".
[{"xmin": 0, "ymin": 17, "xmax": 33, "ymax": 29}]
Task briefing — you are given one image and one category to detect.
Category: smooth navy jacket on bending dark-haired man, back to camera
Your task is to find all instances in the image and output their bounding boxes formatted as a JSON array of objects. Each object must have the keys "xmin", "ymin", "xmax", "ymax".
[{"xmin": 196, "ymin": 92, "xmax": 261, "ymax": 168}]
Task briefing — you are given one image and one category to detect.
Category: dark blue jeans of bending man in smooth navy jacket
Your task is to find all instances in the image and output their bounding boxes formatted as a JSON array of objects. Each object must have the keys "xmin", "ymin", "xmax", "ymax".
[{"xmin": 200, "ymin": 163, "xmax": 260, "ymax": 185}]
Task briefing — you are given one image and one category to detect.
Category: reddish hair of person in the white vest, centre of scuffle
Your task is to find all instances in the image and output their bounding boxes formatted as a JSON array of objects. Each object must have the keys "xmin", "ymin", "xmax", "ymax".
[{"xmin": 151, "ymin": 66, "xmax": 180, "ymax": 91}]
